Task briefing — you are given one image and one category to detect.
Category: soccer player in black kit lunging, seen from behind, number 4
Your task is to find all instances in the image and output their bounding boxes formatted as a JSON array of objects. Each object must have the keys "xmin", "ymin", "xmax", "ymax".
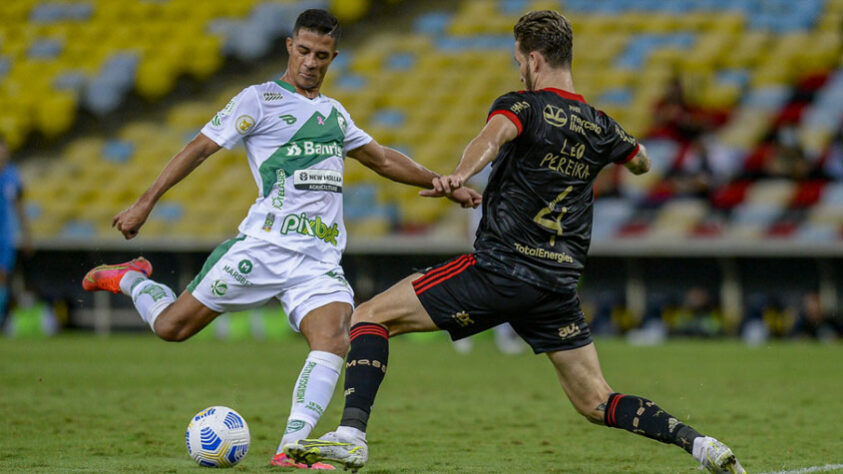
[{"xmin": 285, "ymin": 11, "xmax": 745, "ymax": 473}]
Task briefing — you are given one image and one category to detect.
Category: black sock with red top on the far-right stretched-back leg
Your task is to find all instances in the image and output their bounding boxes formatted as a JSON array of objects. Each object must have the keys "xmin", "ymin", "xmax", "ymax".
[{"xmin": 603, "ymin": 393, "xmax": 702, "ymax": 453}]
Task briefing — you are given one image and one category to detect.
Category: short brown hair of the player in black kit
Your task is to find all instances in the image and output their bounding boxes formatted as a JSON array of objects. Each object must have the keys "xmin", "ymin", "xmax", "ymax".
[{"xmin": 512, "ymin": 10, "xmax": 574, "ymax": 68}]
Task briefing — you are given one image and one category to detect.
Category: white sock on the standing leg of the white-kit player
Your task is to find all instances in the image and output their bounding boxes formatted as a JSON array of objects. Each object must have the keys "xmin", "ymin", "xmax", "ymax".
[{"xmin": 276, "ymin": 351, "xmax": 343, "ymax": 453}]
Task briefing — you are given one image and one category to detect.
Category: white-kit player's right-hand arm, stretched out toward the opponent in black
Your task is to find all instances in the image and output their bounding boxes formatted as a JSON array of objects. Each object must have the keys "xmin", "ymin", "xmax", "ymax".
[{"xmin": 348, "ymin": 140, "xmax": 481, "ymax": 207}]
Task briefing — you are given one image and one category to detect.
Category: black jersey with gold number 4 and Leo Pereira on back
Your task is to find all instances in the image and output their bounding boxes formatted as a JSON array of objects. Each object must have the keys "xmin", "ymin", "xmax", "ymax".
[{"xmin": 474, "ymin": 89, "xmax": 638, "ymax": 290}]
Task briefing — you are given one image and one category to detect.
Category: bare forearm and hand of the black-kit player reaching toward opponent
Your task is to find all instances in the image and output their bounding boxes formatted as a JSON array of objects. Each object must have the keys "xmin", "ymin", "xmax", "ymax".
[{"xmin": 419, "ymin": 115, "xmax": 518, "ymax": 197}]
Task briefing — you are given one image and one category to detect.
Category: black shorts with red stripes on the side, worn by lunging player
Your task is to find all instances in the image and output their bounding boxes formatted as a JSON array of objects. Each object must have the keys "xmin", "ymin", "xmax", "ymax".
[{"xmin": 413, "ymin": 254, "xmax": 591, "ymax": 354}]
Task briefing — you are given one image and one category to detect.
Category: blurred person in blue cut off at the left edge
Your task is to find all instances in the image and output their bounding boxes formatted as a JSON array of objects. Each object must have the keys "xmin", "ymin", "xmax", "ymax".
[{"xmin": 0, "ymin": 138, "xmax": 32, "ymax": 327}]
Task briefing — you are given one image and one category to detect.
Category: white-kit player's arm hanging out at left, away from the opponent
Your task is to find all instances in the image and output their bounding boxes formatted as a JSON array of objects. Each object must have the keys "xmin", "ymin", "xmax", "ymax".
[{"xmin": 111, "ymin": 133, "xmax": 220, "ymax": 239}]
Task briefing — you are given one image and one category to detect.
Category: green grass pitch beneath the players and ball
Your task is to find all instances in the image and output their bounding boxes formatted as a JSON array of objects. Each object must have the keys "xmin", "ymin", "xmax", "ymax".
[{"xmin": 0, "ymin": 335, "xmax": 843, "ymax": 473}]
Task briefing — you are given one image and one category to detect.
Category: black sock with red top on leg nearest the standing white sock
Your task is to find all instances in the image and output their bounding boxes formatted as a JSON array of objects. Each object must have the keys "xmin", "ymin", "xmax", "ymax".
[{"xmin": 340, "ymin": 323, "xmax": 389, "ymax": 431}]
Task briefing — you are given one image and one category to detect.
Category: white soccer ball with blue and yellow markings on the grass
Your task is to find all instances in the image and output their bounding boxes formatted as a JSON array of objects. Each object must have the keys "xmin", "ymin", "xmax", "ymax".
[{"xmin": 185, "ymin": 407, "xmax": 249, "ymax": 467}]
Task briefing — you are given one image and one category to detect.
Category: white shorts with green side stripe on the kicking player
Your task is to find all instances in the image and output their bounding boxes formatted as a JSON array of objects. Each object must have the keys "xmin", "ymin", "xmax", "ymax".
[{"xmin": 187, "ymin": 235, "xmax": 354, "ymax": 331}]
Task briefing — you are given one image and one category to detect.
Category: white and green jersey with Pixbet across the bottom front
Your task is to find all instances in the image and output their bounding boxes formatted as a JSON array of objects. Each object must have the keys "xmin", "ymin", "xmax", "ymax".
[{"xmin": 202, "ymin": 81, "xmax": 372, "ymax": 263}]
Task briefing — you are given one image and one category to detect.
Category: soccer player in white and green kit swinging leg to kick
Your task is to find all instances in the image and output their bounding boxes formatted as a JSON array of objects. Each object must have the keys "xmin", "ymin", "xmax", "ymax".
[{"xmin": 83, "ymin": 10, "xmax": 480, "ymax": 469}]
